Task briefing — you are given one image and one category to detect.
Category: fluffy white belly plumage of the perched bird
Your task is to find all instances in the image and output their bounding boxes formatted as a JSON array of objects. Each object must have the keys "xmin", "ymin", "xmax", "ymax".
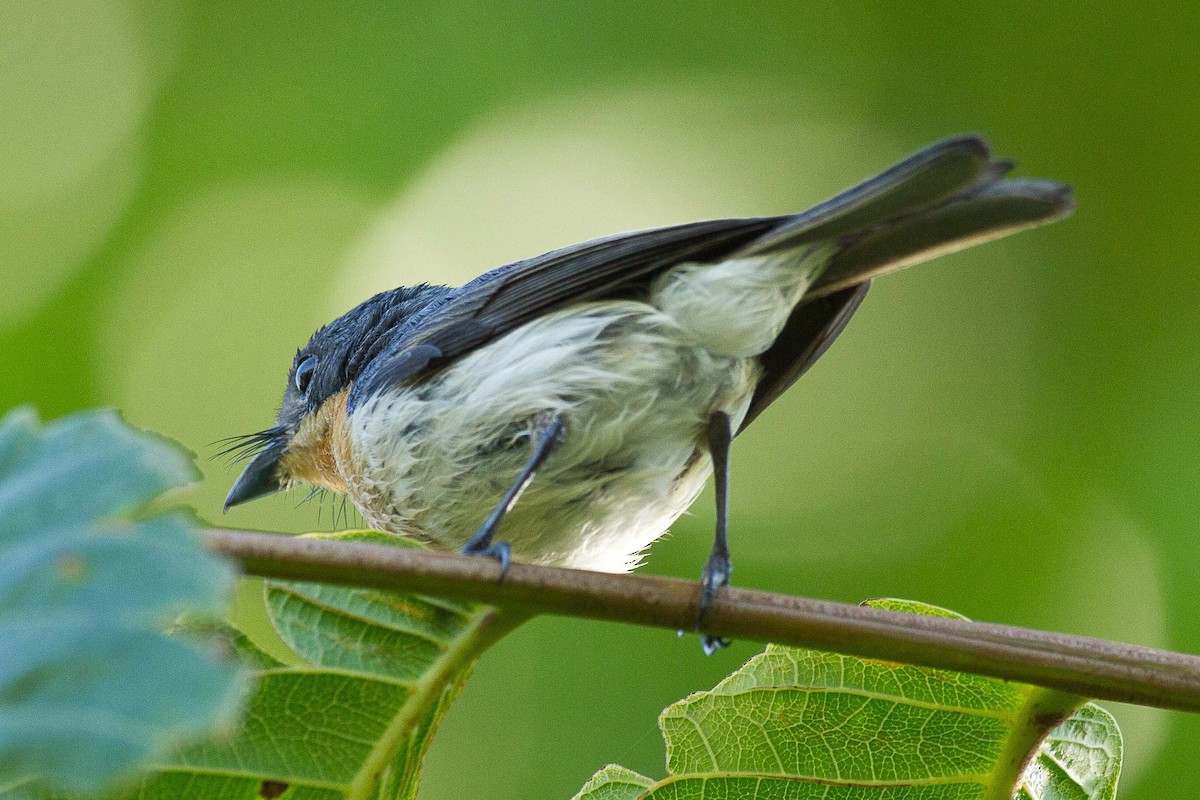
[{"xmin": 341, "ymin": 248, "xmax": 808, "ymax": 571}]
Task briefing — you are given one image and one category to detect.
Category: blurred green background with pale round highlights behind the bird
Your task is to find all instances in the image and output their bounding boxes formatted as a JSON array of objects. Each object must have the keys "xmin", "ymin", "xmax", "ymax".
[{"xmin": 0, "ymin": 0, "xmax": 1200, "ymax": 800}]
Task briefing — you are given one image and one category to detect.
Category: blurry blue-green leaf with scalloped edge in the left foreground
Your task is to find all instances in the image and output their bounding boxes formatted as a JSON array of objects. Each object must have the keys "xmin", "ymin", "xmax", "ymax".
[{"xmin": 0, "ymin": 410, "xmax": 244, "ymax": 796}]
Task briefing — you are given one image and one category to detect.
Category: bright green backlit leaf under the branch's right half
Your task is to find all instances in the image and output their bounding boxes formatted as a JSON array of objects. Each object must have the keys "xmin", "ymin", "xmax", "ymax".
[{"xmin": 576, "ymin": 601, "xmax": 1121, "ymax": 800}]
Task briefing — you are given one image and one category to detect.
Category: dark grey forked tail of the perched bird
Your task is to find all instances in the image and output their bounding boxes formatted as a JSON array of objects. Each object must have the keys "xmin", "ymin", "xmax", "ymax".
[{"xmin": 742, "ymin": 137, "xmax": 1074, "ymax": 301}]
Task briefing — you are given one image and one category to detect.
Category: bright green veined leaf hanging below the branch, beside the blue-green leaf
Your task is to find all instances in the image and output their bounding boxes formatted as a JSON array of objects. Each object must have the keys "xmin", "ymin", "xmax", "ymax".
[{"xmin": 123, "ymin": 533, "xmax": 524, "ymax": 800}]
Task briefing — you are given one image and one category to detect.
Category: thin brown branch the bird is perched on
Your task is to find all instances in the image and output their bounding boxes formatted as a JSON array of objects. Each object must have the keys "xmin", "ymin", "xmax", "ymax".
[{"xmin": 203, "ymin": 530, "xmax": 1200, "ymax": 711}]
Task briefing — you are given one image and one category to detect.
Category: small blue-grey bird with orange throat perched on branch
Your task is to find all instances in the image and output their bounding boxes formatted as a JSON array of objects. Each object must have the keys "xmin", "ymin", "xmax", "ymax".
[{"xmin": 224, "ymin": 136, "xmax": 1074, "ymax": 652}]
